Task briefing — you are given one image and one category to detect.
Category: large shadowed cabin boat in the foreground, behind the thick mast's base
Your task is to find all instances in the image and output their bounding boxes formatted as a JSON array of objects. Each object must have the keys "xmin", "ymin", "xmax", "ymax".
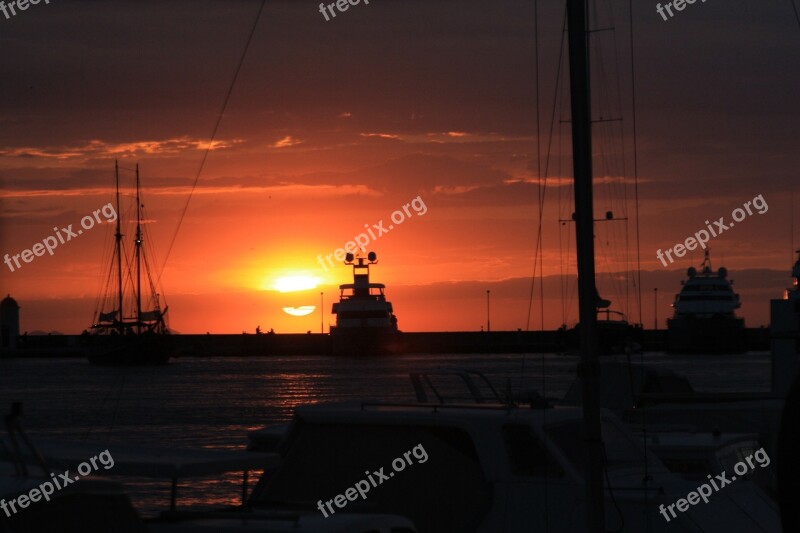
[{"xmin": 241, "ymin": 402, "xmax": 780, "ymax": 533}]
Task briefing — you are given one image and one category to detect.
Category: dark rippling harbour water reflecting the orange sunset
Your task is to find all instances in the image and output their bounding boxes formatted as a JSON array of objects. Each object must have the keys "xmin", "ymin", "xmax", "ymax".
[{"xmin": 0, "ymin": 353, "xmax": 770, "ymax": 516}]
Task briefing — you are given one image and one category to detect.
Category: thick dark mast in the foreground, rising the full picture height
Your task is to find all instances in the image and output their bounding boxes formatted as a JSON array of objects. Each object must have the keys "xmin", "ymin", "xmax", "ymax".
[{"xmin": 567, "ymin": 0, "xmax": 605, "ymax": 533}]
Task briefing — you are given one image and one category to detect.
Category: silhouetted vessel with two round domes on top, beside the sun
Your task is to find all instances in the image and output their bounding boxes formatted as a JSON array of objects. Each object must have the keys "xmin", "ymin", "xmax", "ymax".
[{"xmin": 331, "ymin": 252, "xmax": 402, "ymax": 355}]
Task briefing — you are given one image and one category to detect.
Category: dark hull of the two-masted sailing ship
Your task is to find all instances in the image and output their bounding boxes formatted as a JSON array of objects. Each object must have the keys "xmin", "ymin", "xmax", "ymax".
[{"xmin": 86, "ymin": 334, "xmax": 173, "ymax": 366}]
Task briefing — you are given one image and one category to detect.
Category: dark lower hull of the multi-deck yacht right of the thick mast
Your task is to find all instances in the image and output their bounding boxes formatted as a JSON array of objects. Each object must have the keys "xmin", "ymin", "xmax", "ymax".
[{"xmin": 667, "ymin": 317, "xmax": 747, "ymax": 353}]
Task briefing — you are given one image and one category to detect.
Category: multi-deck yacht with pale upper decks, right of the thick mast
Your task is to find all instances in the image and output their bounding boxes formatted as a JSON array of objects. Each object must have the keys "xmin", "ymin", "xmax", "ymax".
[{"xmin": 667, "ymin": 250, "xmax": 746, "ymax": 353}]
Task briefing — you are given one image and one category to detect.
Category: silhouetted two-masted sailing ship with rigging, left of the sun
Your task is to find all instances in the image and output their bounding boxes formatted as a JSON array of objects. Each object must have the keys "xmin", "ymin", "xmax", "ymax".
[{"xmin": 85, "ymin": 162, "xmax": 172, "ymax": 366}]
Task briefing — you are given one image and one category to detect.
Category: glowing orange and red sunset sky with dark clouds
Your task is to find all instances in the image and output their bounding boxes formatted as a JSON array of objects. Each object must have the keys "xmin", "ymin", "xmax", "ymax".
[{"xmin": 0, "ymin": 0, "xmax": 800, "ymax": 333}]
